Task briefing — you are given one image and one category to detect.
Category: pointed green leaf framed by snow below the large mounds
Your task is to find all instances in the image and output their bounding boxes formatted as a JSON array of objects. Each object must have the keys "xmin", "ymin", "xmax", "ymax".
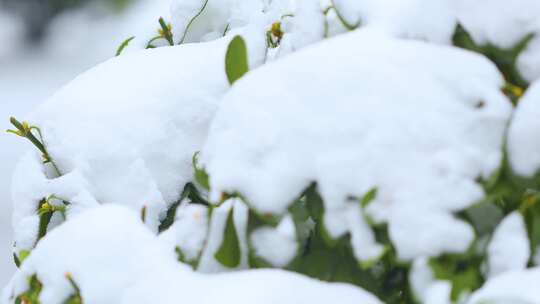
[{"xmin": 214, "ymin": 208, "xmax": 240, "ymax": 268}]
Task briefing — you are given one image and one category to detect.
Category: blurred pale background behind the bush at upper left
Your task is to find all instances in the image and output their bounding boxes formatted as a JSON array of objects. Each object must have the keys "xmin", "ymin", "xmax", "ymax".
[{"xmin": 0, "ymin": 0, "xmax": 160, "ymax": 284}]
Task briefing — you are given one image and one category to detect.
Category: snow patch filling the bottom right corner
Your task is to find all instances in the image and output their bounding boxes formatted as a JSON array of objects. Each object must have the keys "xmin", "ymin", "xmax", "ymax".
[{"xmin": 467, "ymin": 268, "xmax": 540, "ymax": 304}]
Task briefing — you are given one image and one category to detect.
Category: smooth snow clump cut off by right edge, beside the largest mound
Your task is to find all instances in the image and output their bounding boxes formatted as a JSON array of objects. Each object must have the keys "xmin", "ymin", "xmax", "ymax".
[{"xmin": 508, "ymin": 81, "xmax": 540, "ymax": 177}]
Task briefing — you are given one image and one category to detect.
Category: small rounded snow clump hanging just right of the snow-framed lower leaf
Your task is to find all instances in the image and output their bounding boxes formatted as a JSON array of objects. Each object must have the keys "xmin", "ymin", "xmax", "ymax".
[{"xmin": 250, "ymin": 215, "xmax": 298, "ymax": 268}]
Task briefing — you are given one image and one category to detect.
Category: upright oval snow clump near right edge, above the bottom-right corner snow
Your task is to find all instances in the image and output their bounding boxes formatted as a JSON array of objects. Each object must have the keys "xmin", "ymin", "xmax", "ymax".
[{"xmin": 487, "ymin": 211, "xmax": 531, "ymax": 278}]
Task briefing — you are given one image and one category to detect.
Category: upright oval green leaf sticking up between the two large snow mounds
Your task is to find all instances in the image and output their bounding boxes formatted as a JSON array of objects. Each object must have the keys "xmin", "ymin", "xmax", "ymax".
[{"xmin": 225, "ymin": 36, "xmax": 249, "ymax": 85}]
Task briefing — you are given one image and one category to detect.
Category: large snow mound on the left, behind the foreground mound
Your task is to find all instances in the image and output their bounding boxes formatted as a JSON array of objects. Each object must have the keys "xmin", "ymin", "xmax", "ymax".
[{"xmin": 9, "ymin": 32, "xmax": 263, "ymax": 253}]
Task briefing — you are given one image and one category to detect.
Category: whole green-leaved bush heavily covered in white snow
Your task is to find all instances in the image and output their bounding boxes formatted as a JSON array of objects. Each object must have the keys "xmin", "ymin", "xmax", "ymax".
[{"xmin": 1, "ymin": 0, "xmax": 540, "ymax": 304}]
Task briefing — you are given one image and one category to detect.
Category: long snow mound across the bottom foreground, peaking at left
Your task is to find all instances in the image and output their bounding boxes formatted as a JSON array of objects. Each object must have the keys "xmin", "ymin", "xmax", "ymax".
[{"xmin": 0, "ymin": 203, "xmax": 381, "ymax": 304}]
